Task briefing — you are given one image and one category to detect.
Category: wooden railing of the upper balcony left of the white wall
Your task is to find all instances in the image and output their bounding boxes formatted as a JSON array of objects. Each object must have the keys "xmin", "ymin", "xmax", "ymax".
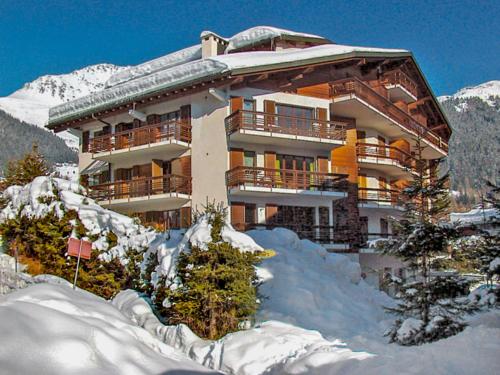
[{"xmin": 89, "ymin": 120, "xmax": 191, "ymax": 154}]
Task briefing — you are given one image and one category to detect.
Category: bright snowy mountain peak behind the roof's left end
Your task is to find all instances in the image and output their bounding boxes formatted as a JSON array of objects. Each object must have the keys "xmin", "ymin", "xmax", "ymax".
[{"xmin": 0, "ymin": 64, "xmax": 124, "ymax": 148}]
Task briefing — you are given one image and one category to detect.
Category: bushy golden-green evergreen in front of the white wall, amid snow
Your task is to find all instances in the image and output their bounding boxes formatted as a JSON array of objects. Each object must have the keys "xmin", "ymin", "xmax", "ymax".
[{"xmin": 158, "ymin": 204, "xmax": 259, "ymax": 339}]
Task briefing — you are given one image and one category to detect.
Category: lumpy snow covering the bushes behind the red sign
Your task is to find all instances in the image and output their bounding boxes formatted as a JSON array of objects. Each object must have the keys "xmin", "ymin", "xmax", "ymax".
[{"xmin": 0, "ymin": 177, "xmax": 159, "ymax": 261}]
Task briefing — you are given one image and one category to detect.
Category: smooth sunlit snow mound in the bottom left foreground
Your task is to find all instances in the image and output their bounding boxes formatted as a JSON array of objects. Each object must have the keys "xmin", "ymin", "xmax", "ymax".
[{"xmin": 0, "ymin": 284, "xmax": 217, "ymax": 375}]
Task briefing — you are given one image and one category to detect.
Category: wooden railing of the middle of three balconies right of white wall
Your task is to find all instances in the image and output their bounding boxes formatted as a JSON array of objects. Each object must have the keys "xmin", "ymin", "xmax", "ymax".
[{"xmin": 226, "ymin": 166, "xmax": 347, "ymax": 191}]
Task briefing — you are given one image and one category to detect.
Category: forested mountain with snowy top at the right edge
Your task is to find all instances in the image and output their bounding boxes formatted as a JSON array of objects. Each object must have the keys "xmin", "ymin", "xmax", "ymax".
[{"xmin": 438, "ymin": 80, "xmax": 500, "ymax": 208}]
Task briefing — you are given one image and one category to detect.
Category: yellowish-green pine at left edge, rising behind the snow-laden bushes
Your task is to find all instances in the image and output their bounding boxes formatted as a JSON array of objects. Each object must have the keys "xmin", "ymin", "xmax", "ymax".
[{"xmin": 0, "ymin": 143, "xmax": 50, "ymax": 191}]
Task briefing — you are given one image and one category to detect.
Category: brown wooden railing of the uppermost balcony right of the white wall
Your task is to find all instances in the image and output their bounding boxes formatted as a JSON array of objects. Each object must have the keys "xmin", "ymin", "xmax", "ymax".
[{"xmin": 226, "ymin": 110, "xmax": 348, "ymax": 141}]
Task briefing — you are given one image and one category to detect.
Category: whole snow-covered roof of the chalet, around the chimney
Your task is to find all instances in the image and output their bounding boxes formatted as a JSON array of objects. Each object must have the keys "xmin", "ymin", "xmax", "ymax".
[{"xmin": 49, "ymin": 26, "xmax": 410, "ymax": 126}]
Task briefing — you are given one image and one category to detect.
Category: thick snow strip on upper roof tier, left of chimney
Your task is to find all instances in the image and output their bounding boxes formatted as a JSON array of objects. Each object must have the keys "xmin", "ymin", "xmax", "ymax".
[{"xmin": 105, "ymin": 44, "xmax": 201, "ymax": 88}]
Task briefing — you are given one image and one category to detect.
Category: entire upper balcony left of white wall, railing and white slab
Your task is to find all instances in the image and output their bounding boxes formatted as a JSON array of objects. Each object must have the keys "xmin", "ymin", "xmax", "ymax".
[{"xmin": 89, "ymin": 120, "xmax": 191, "ymax": 164}]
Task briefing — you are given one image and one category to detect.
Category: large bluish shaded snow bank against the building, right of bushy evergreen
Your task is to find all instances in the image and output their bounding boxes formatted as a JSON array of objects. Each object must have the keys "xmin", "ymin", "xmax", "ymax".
[{"xmin": 247, "ymin": 228, "xmax": 392, "ymax": 339}]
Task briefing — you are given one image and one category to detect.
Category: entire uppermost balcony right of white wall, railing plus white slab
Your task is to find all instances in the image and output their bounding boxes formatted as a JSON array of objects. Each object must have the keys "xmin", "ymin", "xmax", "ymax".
[{"xmin": 225, "ymin": 110, "xmax": 349, "ymax": 150}]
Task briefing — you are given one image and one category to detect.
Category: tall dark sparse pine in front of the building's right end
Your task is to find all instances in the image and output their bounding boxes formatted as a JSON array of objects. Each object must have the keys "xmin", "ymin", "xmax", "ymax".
[{"xmin": 382, "ymin": 138, "xmax": 474, "ymax": 345}]
